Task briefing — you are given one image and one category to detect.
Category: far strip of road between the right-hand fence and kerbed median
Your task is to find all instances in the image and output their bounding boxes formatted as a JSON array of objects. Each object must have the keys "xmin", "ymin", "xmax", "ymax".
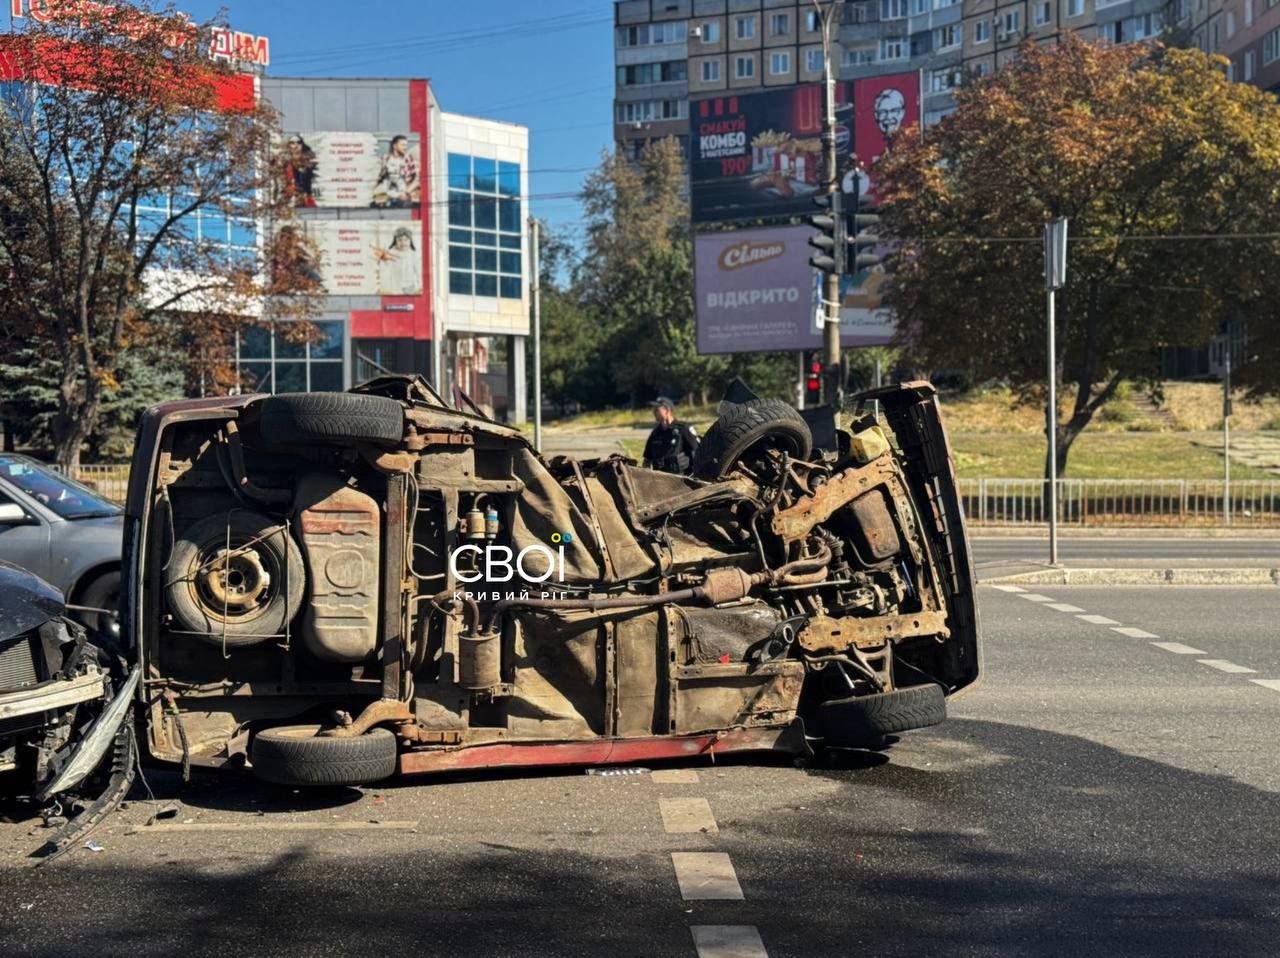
[{"xmin": 973, "ymin": 530, "xmax": 1280, "ymax": 569}]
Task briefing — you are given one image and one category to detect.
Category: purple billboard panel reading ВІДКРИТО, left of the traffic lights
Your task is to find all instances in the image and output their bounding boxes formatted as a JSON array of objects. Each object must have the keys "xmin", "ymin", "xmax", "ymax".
[{"xmin": 694, "ymin": 227, "xmax": 814, "ymax": 353}]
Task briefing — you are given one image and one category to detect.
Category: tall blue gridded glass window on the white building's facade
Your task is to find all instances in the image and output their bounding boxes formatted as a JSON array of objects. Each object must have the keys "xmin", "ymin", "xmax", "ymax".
[{"xmin": 448, "ymin": 152, "xmax": 525, "ymax": 300}]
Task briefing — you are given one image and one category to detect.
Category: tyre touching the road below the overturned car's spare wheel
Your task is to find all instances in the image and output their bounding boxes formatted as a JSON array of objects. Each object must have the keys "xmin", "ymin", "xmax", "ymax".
[{"xmin": 250, "ymin": 725, "xmax": 397, "ymax": 785}]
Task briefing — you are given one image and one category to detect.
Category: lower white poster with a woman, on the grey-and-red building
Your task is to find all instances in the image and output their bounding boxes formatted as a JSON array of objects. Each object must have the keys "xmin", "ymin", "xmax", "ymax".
[{"xmin": 306, "ymin": 219, "xmax": 424, "ymax": 296}]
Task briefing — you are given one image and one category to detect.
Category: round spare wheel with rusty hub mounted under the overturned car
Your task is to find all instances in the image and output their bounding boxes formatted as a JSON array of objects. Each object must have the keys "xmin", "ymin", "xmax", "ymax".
[{"xmin": 165, "ymin": 511, "xmax": 306, "ymax": 648}]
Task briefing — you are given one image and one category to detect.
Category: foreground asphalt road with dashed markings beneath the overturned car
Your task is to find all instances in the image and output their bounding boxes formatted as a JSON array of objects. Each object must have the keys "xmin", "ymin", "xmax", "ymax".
[{"xmin": 0, "ymin": 587, "xmax": 1280, "ymax": 958}]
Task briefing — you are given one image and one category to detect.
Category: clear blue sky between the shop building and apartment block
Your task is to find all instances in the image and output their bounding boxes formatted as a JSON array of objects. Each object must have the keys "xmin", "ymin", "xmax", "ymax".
[{"xmin": 177, "ymin": 0, "xmax": 613, "ymax": 238}]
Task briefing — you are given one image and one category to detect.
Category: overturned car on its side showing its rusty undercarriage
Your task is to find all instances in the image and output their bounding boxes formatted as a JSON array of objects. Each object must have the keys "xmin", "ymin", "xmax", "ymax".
[{"xmin": 123, "ymin": 377, "xmax": 979, "ymax": 785}]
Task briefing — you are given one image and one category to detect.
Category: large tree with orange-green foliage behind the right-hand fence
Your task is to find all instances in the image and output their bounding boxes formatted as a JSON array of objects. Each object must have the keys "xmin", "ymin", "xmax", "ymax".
[{"xmin": 874, "ymin": 36, "xmax": 1280, "ymax": 470}]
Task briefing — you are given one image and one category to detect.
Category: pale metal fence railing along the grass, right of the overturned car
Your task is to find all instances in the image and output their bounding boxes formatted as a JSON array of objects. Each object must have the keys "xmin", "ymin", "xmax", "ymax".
[{"xmin": 960, "ymin": 479, "xmax": 1280, "ymax": 528}]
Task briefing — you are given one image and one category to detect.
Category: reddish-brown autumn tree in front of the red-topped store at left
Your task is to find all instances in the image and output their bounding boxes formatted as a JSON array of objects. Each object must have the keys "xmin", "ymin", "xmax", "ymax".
[{"xmin": 0, "ymin": 0, "xmax": 315, "ymax": 467}]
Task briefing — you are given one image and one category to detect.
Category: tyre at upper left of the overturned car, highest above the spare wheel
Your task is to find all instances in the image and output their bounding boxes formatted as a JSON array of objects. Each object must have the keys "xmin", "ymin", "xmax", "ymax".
[{"xmin": 259, "ymin": 392, "xmax": 404, "ymax": 446}]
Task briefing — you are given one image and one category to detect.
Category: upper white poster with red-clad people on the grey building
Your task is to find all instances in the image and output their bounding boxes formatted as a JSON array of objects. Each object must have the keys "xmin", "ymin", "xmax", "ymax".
[{"xmin": 279, "ymin": 132, "xmax": 422, "ymax": 210}]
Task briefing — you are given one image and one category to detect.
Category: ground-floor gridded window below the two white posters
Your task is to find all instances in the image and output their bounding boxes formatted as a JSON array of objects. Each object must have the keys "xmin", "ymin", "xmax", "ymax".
[{"xmin": 236, "ymin": 319, "xmax": 347, "ymax": 392}]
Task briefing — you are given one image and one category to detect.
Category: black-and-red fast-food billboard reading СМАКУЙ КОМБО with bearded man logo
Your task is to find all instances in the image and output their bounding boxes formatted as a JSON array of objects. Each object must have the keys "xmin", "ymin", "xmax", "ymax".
[{"xmin": 689, "ymin": 73, "xmax": 920, "ymax": 223}]
